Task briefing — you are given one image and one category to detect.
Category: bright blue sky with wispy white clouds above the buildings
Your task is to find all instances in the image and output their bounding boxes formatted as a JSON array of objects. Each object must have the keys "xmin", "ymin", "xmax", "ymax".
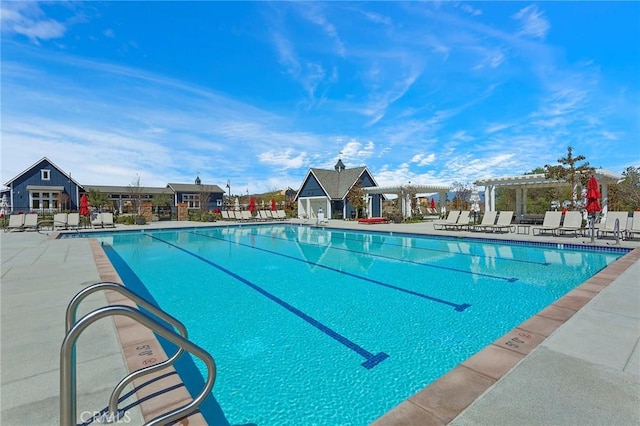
[{"xmin": 0, "ymin": 1, "xmax": 640, "ymax": 194}]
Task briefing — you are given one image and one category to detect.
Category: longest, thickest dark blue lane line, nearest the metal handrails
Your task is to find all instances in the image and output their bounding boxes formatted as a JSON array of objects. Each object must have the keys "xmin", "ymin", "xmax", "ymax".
[{"xmin": 145, "ymin": 233, "xmax": 389, "ymax": 370}]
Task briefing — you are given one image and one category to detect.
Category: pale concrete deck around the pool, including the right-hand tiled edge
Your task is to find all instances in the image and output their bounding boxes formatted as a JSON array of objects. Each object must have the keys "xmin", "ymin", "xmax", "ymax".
[{"xmin": 0, "ymin": 220, "xmax": 640, "ymax": 426}]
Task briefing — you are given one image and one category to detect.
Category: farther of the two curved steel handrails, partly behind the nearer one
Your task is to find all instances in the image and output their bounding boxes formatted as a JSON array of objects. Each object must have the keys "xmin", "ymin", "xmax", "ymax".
[{"xmin": 65, "ymin": 281, "xmax": 194, "ymax": 422}]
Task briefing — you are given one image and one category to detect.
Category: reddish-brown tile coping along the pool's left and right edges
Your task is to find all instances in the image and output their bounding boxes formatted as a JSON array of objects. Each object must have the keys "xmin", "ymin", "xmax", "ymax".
[{"xmin": 90, "ymin": 239, "xmax": 640, "ymax": 426}]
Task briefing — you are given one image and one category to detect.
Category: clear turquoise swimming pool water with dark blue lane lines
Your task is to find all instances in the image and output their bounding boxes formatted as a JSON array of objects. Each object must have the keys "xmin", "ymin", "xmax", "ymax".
[{"xmin": 81, "ymin": 224, "xmax": 624, "ymax": 426}]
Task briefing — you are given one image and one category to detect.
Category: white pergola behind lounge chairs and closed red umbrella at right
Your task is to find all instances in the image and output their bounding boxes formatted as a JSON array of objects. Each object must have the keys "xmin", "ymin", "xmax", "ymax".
[{"xmin": 474, "ymin": 169, "xmax": 624, "ymax": 217}]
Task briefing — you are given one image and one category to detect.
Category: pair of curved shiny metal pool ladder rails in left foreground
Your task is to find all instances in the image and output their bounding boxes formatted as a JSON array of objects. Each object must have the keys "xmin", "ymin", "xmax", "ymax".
[{"xmin": 60, "ymin": 282, "xmax": 216, "ymax": 426}]
